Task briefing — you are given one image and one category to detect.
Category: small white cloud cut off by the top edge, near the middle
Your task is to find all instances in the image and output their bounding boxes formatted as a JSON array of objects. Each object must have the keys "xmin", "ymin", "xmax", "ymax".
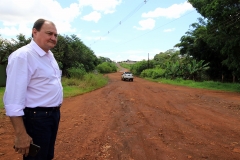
[{"xmin": 79, "ymin": 0, "xmax": 122, "ymax": 14}]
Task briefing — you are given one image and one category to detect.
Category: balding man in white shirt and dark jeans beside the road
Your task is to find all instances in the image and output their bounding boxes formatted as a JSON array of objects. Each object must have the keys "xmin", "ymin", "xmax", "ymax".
[{"xmin": 3, "ymin": 19, "xmax": 63, "ymax": 160}]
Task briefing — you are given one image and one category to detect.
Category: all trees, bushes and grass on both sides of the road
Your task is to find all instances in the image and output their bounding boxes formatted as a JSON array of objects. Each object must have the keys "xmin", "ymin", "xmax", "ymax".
[{"xmin": 0, "ymin": 0, "xmax": 240, "ymax": 107}]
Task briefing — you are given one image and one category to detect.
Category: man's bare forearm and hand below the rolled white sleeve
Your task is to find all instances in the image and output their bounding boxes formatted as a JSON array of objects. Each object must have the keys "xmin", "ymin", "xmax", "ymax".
[{"xmin": 10, "ymin": 117, "xmax": 32, "ymax": 157}]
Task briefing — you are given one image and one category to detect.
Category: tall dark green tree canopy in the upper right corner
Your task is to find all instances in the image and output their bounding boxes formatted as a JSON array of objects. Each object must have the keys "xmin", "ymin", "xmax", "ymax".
[{"xmin": 176, "ymin": 0, "xmax": 240, "ymax": 81}]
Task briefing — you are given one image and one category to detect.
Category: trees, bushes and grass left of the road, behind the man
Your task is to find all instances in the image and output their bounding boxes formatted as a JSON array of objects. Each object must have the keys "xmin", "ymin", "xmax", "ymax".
[{"xmin": 0, "ymin": 34, "xmax": 117, "ymax": 109}]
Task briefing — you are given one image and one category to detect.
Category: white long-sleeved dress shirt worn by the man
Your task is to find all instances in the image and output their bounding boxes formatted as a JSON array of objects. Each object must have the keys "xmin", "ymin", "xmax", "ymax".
[{"xmin": 3, "ymin": 40, "xmax": 63, "ymax": 116}]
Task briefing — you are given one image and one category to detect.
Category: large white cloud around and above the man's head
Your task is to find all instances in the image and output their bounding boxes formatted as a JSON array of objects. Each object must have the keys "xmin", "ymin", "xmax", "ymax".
[{"xmin": 0, "ymin": 0, "xmax": 80, "ymax": 36}]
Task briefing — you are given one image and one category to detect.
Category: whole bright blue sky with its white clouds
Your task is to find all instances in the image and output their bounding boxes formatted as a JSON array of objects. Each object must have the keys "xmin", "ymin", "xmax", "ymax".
[{"xmin": 0, "ymin": 0, "xmax": 201, "ymax": 61}]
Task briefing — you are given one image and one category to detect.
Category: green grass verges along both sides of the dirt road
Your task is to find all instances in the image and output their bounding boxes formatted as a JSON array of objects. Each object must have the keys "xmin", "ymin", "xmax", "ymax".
[{"xmin": 0, "ymin": 74, "xmax": 240, "ymax": 108}]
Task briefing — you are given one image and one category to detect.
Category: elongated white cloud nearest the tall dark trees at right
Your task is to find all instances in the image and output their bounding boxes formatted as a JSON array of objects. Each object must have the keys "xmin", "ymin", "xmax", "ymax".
[{"xmin": 142, "ymin": 1, "xmax": 194, "ymax": 19}]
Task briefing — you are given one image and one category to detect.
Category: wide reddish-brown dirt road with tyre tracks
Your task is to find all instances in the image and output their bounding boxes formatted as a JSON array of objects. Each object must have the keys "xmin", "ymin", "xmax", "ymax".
[{"xmin": 0, "ymin": 72, "xmax": 240, "ymax": 160}]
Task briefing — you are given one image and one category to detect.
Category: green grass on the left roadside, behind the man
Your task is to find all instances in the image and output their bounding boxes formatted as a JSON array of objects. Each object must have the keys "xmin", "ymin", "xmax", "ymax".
[{"xmin": 0, "ymin": 73, "xmax": 108, "ymax": 109}]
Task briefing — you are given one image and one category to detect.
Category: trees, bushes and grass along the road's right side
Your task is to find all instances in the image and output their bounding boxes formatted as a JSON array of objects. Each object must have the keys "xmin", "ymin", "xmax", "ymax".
[{"xmin": 119, "ymin": 0, "xmax": 240, "ymax": 92}]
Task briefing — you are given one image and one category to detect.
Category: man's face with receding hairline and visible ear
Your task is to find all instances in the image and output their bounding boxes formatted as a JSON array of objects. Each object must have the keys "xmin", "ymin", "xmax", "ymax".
[{"xmin": 32, "ymin": 21, "xmax": 57, "ymax": 52}]
